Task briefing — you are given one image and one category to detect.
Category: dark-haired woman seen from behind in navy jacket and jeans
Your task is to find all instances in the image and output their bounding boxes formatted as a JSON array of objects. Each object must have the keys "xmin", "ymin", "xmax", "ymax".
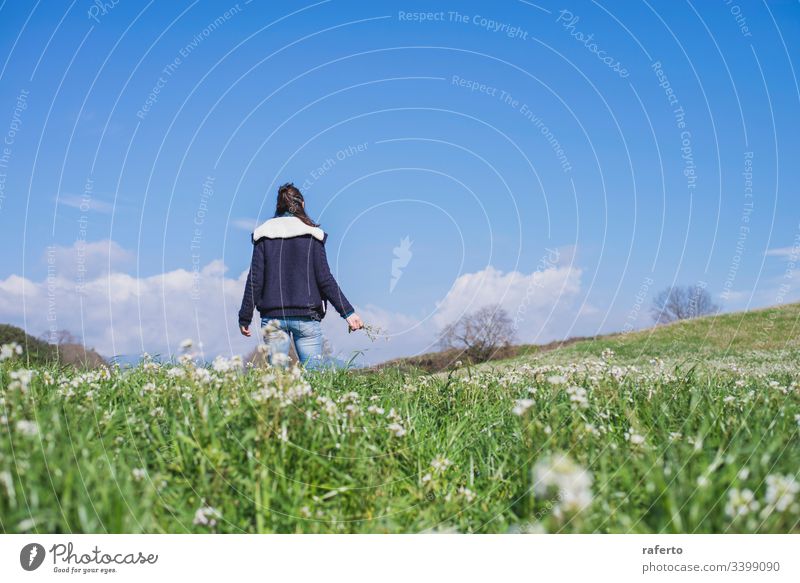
[{"xmin": 239, "ymin": 183, "xmax": 364, "ymax": 368}]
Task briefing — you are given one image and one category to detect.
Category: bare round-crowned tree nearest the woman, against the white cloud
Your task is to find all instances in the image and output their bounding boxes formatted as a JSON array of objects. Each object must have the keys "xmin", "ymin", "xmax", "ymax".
[{"xmin": 439, "ymin": 305, "xmax": 514, "ymax": 362}]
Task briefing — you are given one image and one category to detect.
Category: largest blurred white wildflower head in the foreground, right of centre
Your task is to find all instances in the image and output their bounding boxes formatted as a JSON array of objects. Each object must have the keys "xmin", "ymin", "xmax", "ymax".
[{"xmin": 532, "ymin": 453, "xmax": 592, "ymax": 518}]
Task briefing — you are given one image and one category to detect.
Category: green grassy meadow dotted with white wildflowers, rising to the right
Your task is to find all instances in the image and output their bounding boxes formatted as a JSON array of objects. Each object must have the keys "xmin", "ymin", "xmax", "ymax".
[{"xmin": 0, "ymin": 304, "xmax": 800, "ymax": 533}]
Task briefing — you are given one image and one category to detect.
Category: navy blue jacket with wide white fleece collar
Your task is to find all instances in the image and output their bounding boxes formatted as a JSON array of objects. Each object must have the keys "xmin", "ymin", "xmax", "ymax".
[{"xmin": 239, "ymin": 216, "xmax": 354, "ymax": 326}]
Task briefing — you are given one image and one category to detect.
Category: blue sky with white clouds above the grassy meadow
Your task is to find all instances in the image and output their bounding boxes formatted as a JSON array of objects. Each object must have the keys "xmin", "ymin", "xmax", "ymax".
[{"xmin": 0, "ymin": 0, "xmax": 800, "ymax": 362}]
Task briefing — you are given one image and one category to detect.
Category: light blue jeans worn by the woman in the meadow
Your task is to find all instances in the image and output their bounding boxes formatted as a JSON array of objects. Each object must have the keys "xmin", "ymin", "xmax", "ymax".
[{"xmin": 261, "ymin": 316, "xmax": 323, "ymax": 369}]
